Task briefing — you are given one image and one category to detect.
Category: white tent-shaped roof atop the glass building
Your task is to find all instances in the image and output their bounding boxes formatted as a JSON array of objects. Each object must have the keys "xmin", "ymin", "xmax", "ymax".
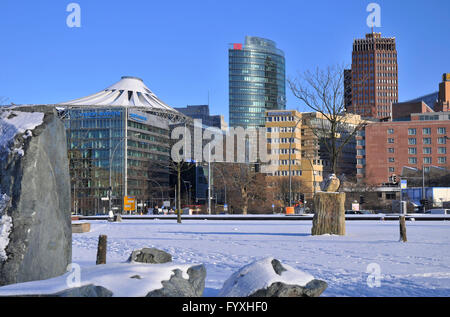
[{"xmin": 60, "ymin": 76, "xmax": 178, "ymax": 113}]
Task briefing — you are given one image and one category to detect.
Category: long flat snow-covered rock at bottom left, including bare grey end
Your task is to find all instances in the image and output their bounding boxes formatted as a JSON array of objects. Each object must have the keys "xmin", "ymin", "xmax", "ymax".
[{"xmin": 0, "ymin": 263, "xmax": 206, "ymax": 297}]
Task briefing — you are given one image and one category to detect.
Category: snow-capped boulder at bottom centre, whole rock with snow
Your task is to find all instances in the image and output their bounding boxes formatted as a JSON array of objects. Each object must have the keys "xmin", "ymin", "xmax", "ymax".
[{"xmin": 218, "ymin": 258, "xmax": 328, "ymax": 297}]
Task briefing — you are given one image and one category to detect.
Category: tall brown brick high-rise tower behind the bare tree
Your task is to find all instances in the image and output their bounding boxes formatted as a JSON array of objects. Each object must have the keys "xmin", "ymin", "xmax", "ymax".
[{"xmin": 345, "ymin": 33, "xmax": 398, "ymax": 119}]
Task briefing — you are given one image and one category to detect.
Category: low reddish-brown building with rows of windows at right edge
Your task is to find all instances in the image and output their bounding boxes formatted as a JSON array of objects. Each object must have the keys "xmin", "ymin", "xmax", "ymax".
[{"xmin": 356, "ymin": 74, "xmax": 450, "ymax": 185}]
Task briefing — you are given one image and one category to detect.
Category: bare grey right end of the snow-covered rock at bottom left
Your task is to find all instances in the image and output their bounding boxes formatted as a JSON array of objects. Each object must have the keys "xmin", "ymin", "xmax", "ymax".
[{"xmin": 147, "ymin": 265, "xmax": 206, "ymax": 297}]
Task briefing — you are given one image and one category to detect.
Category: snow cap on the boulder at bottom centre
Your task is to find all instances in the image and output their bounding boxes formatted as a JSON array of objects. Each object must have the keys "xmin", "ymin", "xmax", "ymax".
[{"xmin": 219, "ymin": 257, "xmax": 314, "ymax": 297}]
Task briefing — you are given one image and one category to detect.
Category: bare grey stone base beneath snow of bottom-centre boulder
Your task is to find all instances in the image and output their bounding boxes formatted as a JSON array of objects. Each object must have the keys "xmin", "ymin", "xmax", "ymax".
[{"xmin": 249, "ymin": 280, "xmax": 328, "ymax": 297}]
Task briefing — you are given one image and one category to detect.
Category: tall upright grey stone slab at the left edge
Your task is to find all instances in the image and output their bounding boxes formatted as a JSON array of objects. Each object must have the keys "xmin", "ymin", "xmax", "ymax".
[{"xmin": 0, "ymin": 107, "xmax": 72, "ymax": 285}]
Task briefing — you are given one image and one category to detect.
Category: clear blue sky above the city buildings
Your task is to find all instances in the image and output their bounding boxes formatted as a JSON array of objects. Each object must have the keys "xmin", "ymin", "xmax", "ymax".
[{"xmin": 0, "ymin": 0, "xmax": 450, "ymax": 121}]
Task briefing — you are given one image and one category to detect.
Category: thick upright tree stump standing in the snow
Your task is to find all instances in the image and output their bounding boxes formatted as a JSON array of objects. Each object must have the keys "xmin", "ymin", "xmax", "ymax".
[{"xmin": 311, "ymin": 192, "xmax": 345, "ymax": 236}]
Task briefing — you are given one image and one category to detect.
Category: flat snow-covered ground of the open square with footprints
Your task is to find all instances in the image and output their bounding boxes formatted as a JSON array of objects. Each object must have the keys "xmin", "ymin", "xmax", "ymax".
[{"xmin": 73, "ymin": 220, "xmax": 450, "ymax": 296}]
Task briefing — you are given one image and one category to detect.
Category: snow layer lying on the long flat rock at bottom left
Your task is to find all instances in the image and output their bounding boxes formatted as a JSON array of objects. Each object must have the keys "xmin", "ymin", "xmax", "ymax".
[{"xmin": 0, "ymin": 263, "xmax": 199, "ymax": 297}]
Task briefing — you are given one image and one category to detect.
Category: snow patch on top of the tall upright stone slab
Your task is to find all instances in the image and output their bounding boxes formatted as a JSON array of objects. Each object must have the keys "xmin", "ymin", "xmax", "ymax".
[{"xmin": 0, "ymin": 110, "xmax": 44, "ymax": 155}]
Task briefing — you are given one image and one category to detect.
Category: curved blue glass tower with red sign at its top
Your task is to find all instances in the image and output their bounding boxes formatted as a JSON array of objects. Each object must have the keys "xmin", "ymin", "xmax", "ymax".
[{"xmin": 228, "ymin": 36, "xmax": 286, "ymax": 127}]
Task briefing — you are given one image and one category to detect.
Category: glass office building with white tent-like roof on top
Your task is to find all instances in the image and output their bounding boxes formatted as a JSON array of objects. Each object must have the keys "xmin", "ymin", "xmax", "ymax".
[{"xmin": 58, "ymin": 76, "xmax": 185, "ymax": 214}]
